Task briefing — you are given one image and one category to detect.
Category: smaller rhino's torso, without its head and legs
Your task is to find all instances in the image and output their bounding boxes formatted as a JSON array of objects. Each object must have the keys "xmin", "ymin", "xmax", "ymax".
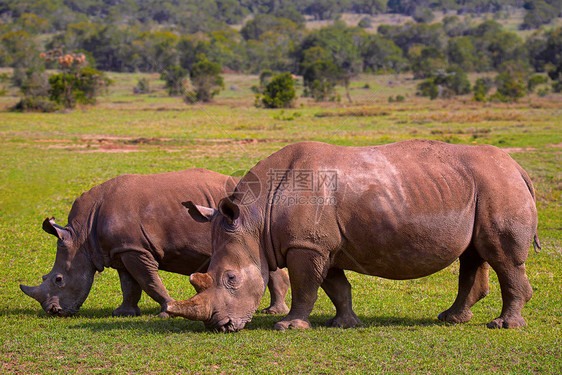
[{"xmin": 77, "ymin": 169, "xmax": 229, "ymax": 274}]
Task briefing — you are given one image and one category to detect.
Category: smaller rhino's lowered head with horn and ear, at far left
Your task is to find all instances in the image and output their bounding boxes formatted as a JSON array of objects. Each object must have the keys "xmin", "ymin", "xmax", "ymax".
[{"xmin": 20, "ymin": 218, "xmax": 96, "ymax": 316}]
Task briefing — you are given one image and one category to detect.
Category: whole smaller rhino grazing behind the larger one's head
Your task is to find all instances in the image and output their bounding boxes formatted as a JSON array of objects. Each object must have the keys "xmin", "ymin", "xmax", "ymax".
[{"xmin": 20, "ymin": 169, "xmax": 289, "ymax": 317}]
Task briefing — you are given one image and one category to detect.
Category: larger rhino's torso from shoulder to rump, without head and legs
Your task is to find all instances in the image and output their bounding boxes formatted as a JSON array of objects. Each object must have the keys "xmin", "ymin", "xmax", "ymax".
[{"xmin": 248, "ymin": 141, "xmax": 529, "ymax": 279}]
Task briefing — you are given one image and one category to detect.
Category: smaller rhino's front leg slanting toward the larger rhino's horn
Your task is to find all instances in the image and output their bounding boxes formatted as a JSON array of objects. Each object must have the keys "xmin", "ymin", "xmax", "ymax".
[{"xmin": 117, "ymin": 251, "xmax": 173, "ymax": 318}]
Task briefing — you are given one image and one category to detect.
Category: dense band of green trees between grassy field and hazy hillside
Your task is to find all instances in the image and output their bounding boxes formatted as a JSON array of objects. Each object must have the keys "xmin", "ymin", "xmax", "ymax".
[{"xmin": 0, "ymin": 14, "xmax": 562, "ymax": 78}]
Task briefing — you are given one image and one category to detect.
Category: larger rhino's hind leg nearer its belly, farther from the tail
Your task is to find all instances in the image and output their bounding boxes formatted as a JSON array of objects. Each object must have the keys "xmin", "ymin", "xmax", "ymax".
[{"xmin": 438, "ymin": 246, "xmax": 490, "ymax": 323}]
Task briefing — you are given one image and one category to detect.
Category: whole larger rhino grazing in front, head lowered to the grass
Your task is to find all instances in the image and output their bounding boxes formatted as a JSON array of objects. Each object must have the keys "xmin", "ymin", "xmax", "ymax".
[{"xmin": 167, "ymin": 140, "xmax": 540, "ymax": 331}]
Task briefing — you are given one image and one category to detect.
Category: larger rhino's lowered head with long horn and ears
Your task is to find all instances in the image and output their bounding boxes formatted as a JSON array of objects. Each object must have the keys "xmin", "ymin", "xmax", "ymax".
[{"xmin": 167, "ymin": 198, "xmax": 269, "ymax": 332}]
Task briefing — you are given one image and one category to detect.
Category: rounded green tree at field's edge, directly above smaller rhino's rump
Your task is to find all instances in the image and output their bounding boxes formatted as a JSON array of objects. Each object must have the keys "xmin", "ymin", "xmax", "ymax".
[{"xmin": 185, "ymin": 55, "xmax": 224, "ymax": 103}]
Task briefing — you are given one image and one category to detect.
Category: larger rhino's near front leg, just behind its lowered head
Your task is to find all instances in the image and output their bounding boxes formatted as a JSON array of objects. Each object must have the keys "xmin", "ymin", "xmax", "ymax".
[{"xmin": 273, "ymin": 249, "xmax": 327, "ymax": 331}]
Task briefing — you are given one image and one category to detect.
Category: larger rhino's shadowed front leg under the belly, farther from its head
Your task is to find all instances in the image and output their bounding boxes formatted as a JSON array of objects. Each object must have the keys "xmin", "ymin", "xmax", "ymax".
[{"xmin": 321, "ymin": 268, "xmax": 362, "ymax": 328}]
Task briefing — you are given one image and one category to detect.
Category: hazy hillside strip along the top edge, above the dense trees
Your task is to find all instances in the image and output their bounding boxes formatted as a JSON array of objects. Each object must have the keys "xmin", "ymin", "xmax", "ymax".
[{"xmin": 0, "ymin": 0, "xmax": 562, "ymax": 33}]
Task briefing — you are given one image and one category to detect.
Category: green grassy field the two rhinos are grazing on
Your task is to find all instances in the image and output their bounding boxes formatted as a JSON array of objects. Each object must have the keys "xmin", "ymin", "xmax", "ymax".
[{"xmin": 0, "ymin": 74, "xmax": 562, "ymax": 374}]
